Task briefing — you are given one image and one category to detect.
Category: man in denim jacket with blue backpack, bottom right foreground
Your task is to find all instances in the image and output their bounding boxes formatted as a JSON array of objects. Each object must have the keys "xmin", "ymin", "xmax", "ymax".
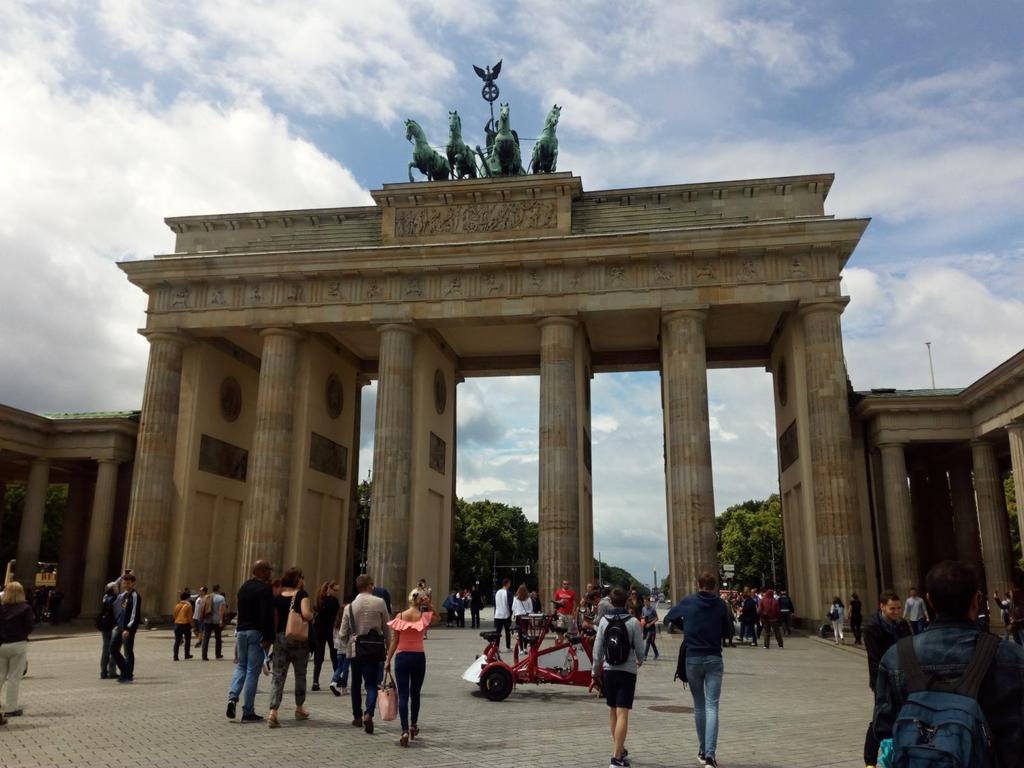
[{"xmin": 874, "ymin": 560, "xmax": 1024, "ymax": 768}]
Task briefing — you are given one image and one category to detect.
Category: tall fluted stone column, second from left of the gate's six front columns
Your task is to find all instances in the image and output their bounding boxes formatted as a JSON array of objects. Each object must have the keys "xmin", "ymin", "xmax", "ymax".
[{"xmin": 240, "ymin": 328, "xmax": 299, "ymax": 579}]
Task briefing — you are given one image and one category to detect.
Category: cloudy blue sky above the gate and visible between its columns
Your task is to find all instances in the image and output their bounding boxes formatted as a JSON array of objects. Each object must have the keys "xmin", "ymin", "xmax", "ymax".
[{"xmin": 0, "ymin": 0, "xmax": 1024, "ymax": 581}]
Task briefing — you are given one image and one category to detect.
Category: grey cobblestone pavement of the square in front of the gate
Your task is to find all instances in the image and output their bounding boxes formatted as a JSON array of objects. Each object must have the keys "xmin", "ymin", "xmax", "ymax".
[{"xmin": 0, "ymin": 623, "xmax": 870, "ymax": 768}]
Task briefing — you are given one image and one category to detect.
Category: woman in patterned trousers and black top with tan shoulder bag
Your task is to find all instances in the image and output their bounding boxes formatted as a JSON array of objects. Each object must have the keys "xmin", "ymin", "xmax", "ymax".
[{"xmin": 266, "ymin": 567, "xmax": 313, "ymax": 728}]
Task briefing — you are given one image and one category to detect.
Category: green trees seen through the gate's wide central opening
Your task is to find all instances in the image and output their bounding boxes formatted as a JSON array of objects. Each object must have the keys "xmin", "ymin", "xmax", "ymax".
[{"xmin": 452, "ymin": 499, "xmax": 538, "ymax": 589}]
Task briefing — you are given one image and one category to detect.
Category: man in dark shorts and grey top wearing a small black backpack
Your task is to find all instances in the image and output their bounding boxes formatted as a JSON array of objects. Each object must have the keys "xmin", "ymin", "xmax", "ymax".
[{"xmin": 591, "ymin": 587, "xmax": 643, "ymax": 768}]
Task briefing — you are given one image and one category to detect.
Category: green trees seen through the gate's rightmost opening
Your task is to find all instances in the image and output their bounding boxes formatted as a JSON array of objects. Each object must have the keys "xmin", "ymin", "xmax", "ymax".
[{"xmin": 715, "ymin": 494, "xmax": 786, "ymax": 586}]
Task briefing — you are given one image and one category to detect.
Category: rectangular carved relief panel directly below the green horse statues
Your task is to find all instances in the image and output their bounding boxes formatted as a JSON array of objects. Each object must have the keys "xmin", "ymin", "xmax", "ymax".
[{"xmin": 394, "ymin": 200, "xmax": 558, "ymax": 238}]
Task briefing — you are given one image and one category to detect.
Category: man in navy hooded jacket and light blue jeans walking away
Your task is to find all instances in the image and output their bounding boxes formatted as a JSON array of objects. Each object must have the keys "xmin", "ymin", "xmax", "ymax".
[{"xmin": 666, "ymin": 570, "xmax": 732, "ymax": 768}]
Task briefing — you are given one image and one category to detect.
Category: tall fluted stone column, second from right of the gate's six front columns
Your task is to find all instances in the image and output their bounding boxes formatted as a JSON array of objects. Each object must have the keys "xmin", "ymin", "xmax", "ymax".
[{"xmin": 662, "ymin": 309, "xmax": 718, "ymax": 598}]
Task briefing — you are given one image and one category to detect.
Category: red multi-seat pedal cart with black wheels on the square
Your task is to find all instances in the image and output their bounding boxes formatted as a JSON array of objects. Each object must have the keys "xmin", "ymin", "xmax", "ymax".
[{"xmin": 463, "ymin": 613, "xmax": 596, "ymax": 701}]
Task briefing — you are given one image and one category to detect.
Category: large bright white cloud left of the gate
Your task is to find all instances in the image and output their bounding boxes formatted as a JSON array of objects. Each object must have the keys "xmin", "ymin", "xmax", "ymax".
[{"xmin": 0, "ymin": 12, "xmax": 369, "ymax": 411}]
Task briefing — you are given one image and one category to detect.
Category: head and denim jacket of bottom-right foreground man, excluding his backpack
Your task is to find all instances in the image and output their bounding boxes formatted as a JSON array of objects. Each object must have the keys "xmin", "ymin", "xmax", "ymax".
[{"xmin": 874, "ymin": 560, "xmax": 1024, "ymax": 768}]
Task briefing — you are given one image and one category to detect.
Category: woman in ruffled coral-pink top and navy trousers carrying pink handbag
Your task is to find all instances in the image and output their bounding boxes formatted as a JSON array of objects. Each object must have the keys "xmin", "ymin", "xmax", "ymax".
[{"xmin": 384, "ymin": 588, "xmax": 440, "ymax": 746}]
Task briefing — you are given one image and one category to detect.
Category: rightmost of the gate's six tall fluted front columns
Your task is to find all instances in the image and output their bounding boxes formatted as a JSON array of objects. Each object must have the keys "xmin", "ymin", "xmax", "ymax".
[{"xmin": 800, "ymin": 299, "xmax": 867, "ymax": 600}]
